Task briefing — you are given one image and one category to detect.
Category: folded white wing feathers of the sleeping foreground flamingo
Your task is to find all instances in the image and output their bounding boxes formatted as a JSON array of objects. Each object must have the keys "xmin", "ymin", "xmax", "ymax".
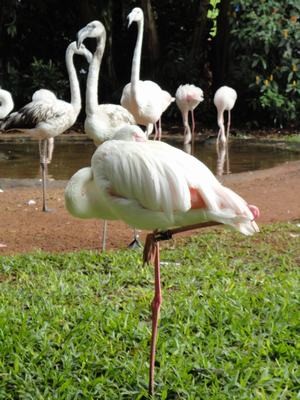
[{"xmin": 92, "ymin": 140, "xmax": 191, "ymax": 216}]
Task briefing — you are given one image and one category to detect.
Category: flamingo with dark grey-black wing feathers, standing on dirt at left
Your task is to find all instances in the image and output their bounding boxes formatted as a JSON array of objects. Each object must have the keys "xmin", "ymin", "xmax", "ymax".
[{"xmin": 1, "ymin": 42, "xmax": 92, "ymax": 211}]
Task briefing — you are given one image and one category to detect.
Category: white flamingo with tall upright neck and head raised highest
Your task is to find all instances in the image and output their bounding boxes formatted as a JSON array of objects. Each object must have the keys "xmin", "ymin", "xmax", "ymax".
[{"xmin": 121, "ymin": 7, "xmax": 175, "ymax": 140}]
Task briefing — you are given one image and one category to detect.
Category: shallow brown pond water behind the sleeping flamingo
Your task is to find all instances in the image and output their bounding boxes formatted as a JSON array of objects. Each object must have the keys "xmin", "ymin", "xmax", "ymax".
[{"xmin": 0, "ymin": 139, "xmax": 300, "ymax": 180}]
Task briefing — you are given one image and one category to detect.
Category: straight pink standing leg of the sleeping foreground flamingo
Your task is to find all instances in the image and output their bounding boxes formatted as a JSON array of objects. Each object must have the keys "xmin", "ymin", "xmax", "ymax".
[{"xmin": 149, "ymin": 242, "xmax": 162, "ymax": 396}]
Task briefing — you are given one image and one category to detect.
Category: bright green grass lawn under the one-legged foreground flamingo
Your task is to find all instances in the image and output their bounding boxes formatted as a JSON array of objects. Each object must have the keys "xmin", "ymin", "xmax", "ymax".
[{"xmin": 0, "ymin": 224, "xmax": 300, "ymax": 400}]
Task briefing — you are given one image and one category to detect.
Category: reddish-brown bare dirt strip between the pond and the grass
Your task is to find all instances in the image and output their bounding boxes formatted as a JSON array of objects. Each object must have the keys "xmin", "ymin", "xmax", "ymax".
[{"xmin": 0, "ymin": 161, "xmax": 300, "ymax": 255}]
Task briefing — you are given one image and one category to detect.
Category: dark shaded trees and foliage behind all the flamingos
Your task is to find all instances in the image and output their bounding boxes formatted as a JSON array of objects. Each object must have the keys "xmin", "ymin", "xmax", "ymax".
[{"xmin": 0, "ymin": 0, "xmax": 300, "ymax": 127}]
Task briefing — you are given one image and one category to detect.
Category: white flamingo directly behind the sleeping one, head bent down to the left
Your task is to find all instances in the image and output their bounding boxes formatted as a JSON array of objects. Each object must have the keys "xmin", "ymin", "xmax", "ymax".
[{"xmin": 77, "ymin": 20, "xmax": 140, "ymax": 250}]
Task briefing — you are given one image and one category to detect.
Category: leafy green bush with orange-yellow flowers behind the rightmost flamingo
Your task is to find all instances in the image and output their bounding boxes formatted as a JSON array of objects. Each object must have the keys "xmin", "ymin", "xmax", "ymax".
[{"xmin": 231, "ymin": 0, "xmax": 300, "ymax": 126}]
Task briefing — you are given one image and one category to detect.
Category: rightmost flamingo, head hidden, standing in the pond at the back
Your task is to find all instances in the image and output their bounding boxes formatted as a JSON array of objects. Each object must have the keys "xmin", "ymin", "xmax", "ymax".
[{"xmin": 214, "ymin": 86, "xmax": 237, "ymax": 144}]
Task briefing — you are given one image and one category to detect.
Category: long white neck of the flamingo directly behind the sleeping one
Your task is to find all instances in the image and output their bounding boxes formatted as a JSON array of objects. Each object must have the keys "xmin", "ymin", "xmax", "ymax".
[{"xmin": 85, "ymin": 33, "xmax": 106, "ymax": 114}]
